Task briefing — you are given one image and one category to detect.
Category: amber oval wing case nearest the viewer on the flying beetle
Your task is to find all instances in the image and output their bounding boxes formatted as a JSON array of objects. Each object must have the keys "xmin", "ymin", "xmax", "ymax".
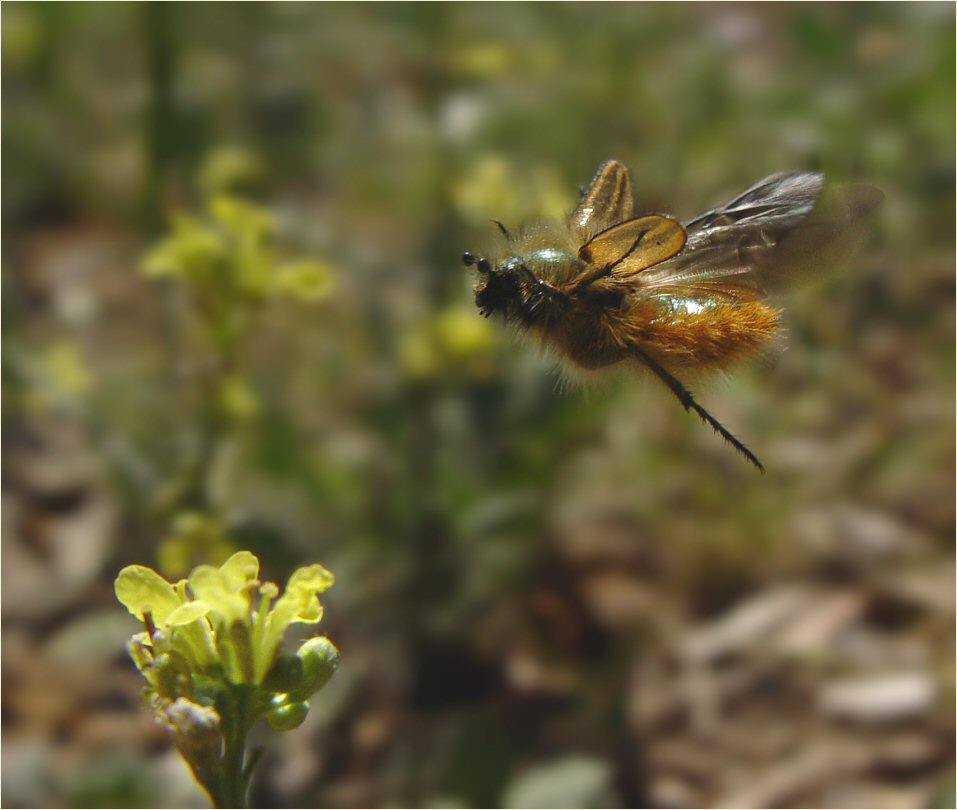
[{"xmin": 578, "ymin": 215, "xmax": 685, "ymax": 278}]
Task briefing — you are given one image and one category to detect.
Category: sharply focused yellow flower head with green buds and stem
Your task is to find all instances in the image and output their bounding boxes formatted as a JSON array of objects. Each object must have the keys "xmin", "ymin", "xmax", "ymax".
[{"xmin": 114, "ymin": 551, "xmax": 339, "ymax": 807}]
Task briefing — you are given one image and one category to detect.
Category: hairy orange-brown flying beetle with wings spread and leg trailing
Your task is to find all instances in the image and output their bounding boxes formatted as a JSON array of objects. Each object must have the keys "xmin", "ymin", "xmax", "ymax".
[{"xmin": 462, "ymin": 160, "xmax": 883, "ymax": 472}]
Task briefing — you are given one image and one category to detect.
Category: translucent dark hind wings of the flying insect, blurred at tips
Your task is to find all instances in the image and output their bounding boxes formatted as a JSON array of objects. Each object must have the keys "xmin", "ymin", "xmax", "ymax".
[{"xmin": 640, "ymin": 171, "xmax": 884, "ymax": 298}]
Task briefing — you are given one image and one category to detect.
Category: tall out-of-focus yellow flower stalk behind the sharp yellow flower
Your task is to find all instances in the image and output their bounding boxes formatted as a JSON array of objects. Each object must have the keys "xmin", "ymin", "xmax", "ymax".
[{"xmin": 142, "ymin": 155, "xmax": 333, "ymax": 576}]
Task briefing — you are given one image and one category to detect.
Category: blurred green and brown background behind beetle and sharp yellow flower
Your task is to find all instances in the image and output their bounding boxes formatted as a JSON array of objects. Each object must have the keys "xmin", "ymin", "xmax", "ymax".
[{"xmin": 2, "ymin": 3, "xmax": 955, "ymax": 807}]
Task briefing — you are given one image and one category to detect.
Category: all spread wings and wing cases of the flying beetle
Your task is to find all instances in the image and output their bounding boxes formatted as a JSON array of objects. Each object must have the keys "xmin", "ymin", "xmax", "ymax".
[{"xmin": 569, "ymin": 160, "xmax": 884, "ymax": 306}]
